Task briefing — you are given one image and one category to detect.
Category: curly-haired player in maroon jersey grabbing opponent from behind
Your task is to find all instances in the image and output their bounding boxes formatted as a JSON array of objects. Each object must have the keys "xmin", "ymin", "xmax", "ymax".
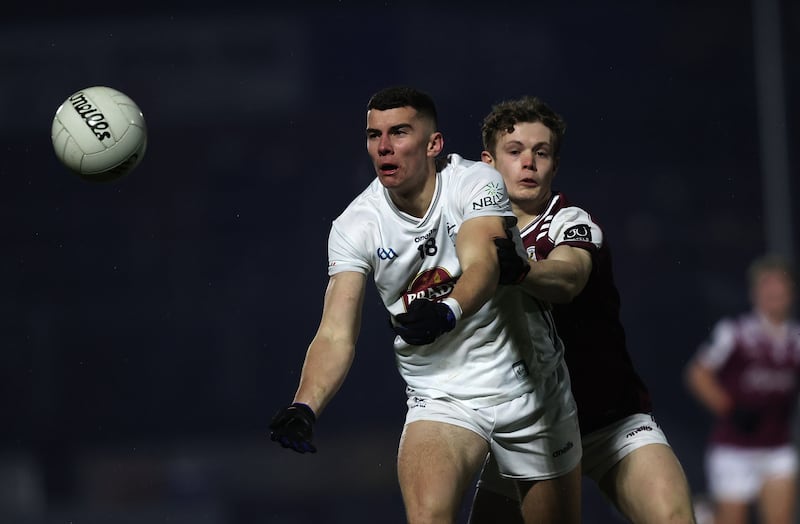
[{"xmin": 471, "ymin": 97, "xmax": 694, "ymax": 524}]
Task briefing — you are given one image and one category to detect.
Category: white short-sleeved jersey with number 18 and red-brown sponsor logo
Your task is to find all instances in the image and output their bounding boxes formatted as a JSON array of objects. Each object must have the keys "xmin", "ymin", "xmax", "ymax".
[{"xmin": 328, "ymin": 155, "xmax": 539, "ymax": 408}]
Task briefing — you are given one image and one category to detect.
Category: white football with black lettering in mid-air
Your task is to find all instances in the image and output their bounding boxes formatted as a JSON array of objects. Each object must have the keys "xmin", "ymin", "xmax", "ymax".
[{"xmin": 50, "ymin": 86, "xmax": 147, "ymax": 181}]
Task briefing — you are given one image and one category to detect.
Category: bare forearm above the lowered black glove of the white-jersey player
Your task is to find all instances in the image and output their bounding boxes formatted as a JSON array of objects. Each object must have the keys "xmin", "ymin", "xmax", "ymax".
[{"xmin": 294, "ymin": 338, "xmax": 355, "ymax": 416}]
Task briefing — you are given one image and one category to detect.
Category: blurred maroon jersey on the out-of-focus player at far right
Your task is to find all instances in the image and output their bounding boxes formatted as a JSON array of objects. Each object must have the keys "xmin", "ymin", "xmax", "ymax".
[{"xmin": 695, "ymin": 313, "xmax": 800, "ymax": 447}]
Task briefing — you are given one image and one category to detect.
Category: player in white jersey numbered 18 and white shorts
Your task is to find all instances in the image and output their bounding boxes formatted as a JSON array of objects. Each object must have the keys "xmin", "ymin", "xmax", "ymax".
[{"xmin": 270, "ymin": 87, "xmax": 580, "ymax": 523}]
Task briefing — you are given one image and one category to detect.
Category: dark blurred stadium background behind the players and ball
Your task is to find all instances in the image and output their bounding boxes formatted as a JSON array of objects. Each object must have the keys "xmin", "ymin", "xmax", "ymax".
[{"xmin": 0, "ymin": 0, "xmax": 800, "ymax": 524}]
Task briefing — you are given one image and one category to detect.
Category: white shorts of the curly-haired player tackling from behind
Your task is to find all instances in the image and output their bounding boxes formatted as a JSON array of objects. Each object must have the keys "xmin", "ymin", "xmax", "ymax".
[{"xmin": 478, "ymin": 413, "xmax": 669, "ymax": 500}]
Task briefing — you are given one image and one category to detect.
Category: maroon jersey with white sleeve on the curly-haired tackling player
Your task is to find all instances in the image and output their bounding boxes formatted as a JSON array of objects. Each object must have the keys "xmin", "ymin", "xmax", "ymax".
[{"xmin": 520, "ymin": 192, "xmax": 652, "ymax": 435}]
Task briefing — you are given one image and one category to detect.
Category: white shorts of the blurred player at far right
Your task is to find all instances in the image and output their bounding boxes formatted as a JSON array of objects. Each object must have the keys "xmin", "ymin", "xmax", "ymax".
[{"xmin": 706, "ymin": 444, "xmax": 797, "ymax": 502}]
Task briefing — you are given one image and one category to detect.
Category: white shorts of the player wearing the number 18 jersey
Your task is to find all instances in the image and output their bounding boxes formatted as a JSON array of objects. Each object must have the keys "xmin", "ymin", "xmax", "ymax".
[{"xmin": 406, "ymin": 364, "xmax": 582, "ymax": 484}]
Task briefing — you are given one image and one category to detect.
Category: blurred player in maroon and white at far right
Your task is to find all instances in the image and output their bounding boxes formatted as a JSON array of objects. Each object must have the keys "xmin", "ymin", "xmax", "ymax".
[{"xmin": 686, "ymin": 255, "xmax": 800, "ymax": 524}]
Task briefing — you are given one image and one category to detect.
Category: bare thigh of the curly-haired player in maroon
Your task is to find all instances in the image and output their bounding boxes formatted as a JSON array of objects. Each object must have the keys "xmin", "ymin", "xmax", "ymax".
[{"xmin": 600, "ymin": 444, "xmax": 694, "ymax": 523}]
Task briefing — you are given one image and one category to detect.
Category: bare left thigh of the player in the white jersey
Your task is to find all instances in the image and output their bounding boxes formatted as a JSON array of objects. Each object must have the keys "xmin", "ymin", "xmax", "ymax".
[{"xmin": 397, "ymin": 420, "xmax": 489, "ymax": 522}]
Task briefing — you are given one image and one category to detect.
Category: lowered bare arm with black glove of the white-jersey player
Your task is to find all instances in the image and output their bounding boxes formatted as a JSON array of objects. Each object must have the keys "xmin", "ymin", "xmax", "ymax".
[{"xmin": 270, "ymin": 272, "xmax": 366, "ymax": 453}]
